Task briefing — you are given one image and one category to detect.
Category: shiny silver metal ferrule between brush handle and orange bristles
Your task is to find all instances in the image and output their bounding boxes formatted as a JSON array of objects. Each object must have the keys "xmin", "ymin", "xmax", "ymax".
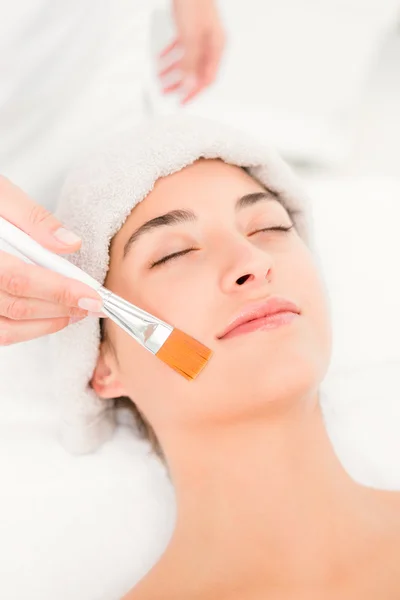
[{"xmin": 97, "ymin": 287, "xmax": 173, "ymax": 354}]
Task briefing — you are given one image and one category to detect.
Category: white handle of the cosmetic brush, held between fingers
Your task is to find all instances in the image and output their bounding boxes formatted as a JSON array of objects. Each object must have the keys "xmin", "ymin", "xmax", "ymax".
[{"xmin": 0, "ymin": 217, "xmax": 102, "ymax": 291}]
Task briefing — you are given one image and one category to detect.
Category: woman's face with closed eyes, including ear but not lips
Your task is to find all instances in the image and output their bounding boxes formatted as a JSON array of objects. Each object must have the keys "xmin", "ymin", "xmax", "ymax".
[{"xmin": 93, "ymin": 160, "xmax": 330, "ymax": 433}]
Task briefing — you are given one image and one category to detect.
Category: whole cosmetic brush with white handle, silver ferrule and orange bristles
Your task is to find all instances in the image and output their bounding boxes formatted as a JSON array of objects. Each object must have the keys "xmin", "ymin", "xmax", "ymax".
[{"xmin": 0, "ymin": 217, "xmax": 212, "ymax": 380}]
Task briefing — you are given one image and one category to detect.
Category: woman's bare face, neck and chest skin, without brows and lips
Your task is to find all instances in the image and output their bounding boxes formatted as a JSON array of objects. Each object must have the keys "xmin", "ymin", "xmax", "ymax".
[{"xmin": 92, "ymin": 160, "xmax": 400, "ymax": 600}]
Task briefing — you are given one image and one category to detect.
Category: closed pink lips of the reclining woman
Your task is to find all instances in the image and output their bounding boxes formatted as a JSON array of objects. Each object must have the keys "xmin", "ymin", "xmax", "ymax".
[{"xmin": 217, "ymin": 296, "xmax": 300, "ymax": 340}]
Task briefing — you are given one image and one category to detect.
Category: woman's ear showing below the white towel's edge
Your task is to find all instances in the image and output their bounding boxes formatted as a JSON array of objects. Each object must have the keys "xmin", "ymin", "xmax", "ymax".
[{"xmin": 91, "ymin": 342, "xmax": 128, "ymax": 399}]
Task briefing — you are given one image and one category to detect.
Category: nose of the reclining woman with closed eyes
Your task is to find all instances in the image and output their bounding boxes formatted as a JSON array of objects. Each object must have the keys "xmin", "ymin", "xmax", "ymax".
[{"xmin": 217, "ymin": 240, "xmax": 273, "ymax": 294}]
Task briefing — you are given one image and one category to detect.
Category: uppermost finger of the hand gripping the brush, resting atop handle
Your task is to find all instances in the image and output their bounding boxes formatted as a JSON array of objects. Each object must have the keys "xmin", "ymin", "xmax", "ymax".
[{"xmin": 0, "ymin": 176, "xmax": 81, "ymax": 253}]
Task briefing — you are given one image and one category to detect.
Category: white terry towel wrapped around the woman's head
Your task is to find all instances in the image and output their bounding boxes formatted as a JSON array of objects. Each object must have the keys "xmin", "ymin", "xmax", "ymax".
[{"xmin": 52, "ymin": 115, "xmax": 310, "ymax": 453}]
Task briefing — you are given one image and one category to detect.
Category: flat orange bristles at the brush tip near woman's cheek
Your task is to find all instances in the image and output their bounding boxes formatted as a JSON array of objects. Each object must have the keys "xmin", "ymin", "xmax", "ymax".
[{"xmin": 156, "ymin": 329, "xmax": 212, "ymax": 381}]
